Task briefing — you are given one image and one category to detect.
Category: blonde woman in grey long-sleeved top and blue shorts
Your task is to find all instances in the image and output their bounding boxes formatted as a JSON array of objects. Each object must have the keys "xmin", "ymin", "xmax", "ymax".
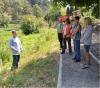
[{"xmin": 82, "ymin": 17, "xmax": 93, "ymax": 69}]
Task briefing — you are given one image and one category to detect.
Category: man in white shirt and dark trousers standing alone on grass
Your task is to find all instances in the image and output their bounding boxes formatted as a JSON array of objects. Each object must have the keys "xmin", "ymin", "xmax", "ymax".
[{"xmin": 9, "ymin": 30, "xmax": 22, "ymax": 70}]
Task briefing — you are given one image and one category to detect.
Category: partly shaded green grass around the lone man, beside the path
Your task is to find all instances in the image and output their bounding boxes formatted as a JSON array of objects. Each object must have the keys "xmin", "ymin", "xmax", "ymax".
[{"xmin": 0, "ymin": 27, "xmax": 59, "ymax": 87}]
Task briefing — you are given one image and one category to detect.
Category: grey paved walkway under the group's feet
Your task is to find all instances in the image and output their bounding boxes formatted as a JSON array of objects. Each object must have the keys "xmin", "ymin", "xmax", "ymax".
[{"xmin": 59, "ymin": 47, "xmax": 99, "ymax": 88}]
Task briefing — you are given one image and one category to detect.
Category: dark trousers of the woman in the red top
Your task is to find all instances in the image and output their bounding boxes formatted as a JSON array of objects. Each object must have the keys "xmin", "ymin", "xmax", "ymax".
[{"xmin": 63, "ymin": 37, "xmax": 72, "ymax": 53}]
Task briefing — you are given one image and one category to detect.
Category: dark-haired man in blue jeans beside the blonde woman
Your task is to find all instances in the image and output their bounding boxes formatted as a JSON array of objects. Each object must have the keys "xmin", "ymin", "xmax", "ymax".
[{"xmin": 72, "ymin": 16, "xmax": 81, "ymax": 62}]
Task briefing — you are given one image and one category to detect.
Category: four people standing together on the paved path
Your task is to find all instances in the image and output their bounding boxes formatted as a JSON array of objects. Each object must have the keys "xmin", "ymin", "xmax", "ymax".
[{"xmin": 57, "ymin": 16, "xmax": 93, "ymax": 69}]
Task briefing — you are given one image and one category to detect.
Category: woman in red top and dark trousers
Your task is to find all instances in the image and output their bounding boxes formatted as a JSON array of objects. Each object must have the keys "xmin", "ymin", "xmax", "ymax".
[{"xmin": 63, "ymin": 18, "xmax": 72, "ymax": 54}]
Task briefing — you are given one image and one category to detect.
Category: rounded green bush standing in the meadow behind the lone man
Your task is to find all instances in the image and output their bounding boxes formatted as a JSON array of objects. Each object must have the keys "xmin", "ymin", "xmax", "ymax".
[{"xmin": 21, "ymin": 15, "xmax": 44, "ymax": 35}]
